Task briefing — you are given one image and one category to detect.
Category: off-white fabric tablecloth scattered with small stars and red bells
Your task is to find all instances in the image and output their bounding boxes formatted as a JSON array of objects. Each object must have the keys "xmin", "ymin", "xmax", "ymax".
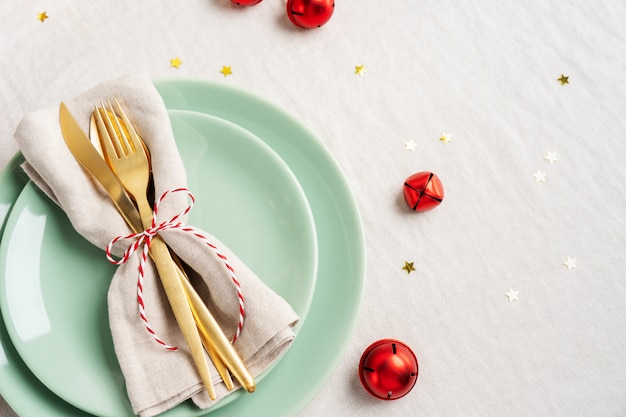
[{"xmin": 0, "ymin": 0, "xmax": 626, "ymax": 417}]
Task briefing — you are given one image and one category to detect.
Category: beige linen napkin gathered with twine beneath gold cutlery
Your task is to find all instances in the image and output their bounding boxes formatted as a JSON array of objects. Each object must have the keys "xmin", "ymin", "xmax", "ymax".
[{"xmin": 15, "ymin": 75, "xmax": 298, "ymax": 417}]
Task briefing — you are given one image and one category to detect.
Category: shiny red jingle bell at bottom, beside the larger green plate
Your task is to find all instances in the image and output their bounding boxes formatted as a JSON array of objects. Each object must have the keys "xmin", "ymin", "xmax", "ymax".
[{"xmin": 359, "ymin": 339, "xmax": 418, "ymax": 400}]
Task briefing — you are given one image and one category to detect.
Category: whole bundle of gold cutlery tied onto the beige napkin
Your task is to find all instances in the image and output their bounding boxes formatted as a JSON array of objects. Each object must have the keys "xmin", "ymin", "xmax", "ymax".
[{"xmin": 59, "ymin": 100, "xmax": 255, "ymax": 400}]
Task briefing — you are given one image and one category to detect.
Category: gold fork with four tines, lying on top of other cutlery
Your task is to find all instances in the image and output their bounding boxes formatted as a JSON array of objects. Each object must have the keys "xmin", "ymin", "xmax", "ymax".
[{"xmin": 96, "ymin": 97, "xmax": 215, "ymax": 398}]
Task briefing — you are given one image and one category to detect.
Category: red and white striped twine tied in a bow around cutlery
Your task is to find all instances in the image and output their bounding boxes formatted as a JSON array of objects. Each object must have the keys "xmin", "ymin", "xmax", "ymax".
[{"xmin": 106, "ymin": 188, "xmax": 246, "ymax": 350}]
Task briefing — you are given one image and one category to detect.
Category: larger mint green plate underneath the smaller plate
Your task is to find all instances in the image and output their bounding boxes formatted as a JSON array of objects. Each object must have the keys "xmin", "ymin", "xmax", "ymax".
[{"xmin": 0, "ymin": 79, "xmax": 365, "ymax": 417}]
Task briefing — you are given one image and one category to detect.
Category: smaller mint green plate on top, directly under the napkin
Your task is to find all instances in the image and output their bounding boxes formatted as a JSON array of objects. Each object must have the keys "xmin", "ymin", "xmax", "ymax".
[{"xmin": 0, "ymin": 110, "xmax": 317, "ymax": 417}]
